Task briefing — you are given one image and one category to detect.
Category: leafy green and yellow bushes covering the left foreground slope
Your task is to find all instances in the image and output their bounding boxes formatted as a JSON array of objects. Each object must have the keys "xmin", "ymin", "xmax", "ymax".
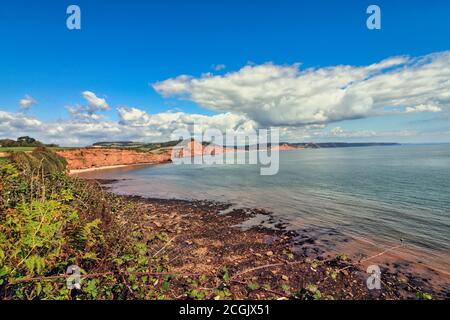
[{"xmin": 0, "ymin": 148, "xmax": 176, "ymax": 299}]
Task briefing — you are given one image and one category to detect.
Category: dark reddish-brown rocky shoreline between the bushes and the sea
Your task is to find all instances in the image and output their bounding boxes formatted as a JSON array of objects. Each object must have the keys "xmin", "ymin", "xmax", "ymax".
[{"xmin": 93, "ymin": 180, "xmax": 450, "ymax": 299}]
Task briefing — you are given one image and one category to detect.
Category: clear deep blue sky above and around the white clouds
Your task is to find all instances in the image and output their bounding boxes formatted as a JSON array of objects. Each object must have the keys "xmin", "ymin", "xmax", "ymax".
[{"xmin": 0, "ymin": 0, "xmax": 450, "ymax": 142}]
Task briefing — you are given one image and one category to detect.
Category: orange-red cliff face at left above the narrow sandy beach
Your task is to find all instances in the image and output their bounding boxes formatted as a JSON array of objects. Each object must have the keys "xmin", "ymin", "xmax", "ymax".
[{"xmin": 57, "ymin": 148, "xmax": 171, "ymax": 170}]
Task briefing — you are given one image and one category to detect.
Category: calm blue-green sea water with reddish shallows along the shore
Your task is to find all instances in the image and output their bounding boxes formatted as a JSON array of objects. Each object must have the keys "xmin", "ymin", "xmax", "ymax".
[{"xmin": 79, "ymin": 145, "xmax": 450, "ymax": 278}]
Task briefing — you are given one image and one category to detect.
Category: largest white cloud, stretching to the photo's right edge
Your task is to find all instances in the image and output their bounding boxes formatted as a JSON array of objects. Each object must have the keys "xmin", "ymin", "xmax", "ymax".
[{"xmin": 152, "ymin": 52, "xmax": 450, "ymax": 126}]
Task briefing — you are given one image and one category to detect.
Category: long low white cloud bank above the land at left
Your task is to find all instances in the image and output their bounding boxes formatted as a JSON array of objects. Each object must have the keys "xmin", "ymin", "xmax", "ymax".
[{"xmin": 0, "ymin": 107, "xmax": 255, "ymax": 146}]
